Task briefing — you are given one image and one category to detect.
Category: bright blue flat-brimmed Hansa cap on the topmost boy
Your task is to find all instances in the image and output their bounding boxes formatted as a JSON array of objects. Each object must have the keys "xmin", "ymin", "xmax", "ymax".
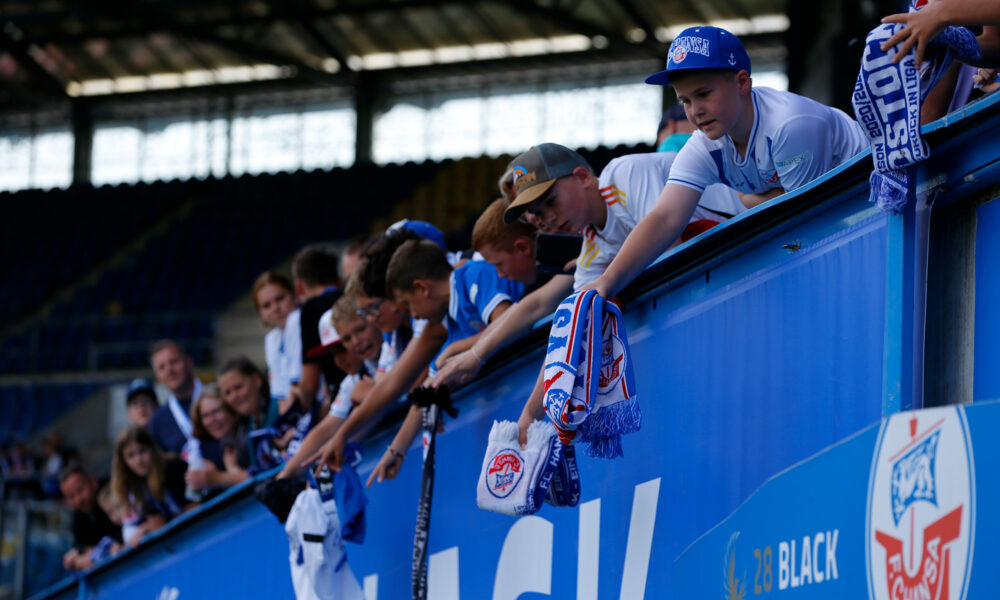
[{"xmin": 646, "ymin": 25, "xmax": 750, "ymax": 85}]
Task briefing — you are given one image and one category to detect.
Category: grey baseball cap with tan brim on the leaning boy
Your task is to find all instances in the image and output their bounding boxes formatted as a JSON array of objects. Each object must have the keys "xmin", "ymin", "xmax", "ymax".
[{"xmin": 503, "ymin": 144, "xmax": 590, "ymax": 224}]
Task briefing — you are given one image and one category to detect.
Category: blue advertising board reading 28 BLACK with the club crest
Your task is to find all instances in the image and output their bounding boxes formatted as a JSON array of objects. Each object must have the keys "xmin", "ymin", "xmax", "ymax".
[{"xmin": 674, "ymin": 402, "xmax": 1000, "ymax": 600}]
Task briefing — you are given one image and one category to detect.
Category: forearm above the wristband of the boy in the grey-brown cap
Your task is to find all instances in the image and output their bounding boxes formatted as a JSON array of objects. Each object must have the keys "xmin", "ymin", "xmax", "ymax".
[{"xmin": 470, "ymin": 275, "xmax": 573, "ymax": 360}]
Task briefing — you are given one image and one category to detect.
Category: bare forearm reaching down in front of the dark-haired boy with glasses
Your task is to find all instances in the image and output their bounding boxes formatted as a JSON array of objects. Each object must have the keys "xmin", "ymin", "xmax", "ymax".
[{"xmin": 338, "ymin": 324, "xmax": 448, "ymax": 439}]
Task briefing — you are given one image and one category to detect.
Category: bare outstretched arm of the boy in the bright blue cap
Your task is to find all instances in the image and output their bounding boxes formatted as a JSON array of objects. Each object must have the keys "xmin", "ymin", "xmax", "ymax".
[{"xmin": 583, "ymin": 183, "xmax": 701, "ymax": 298}]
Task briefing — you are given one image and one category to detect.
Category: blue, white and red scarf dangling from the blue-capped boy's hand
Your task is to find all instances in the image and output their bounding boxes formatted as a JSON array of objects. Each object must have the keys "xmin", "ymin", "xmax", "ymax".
[{"xmin": 543, "ymin": 290, "xmax": 642, "ymax": 458}]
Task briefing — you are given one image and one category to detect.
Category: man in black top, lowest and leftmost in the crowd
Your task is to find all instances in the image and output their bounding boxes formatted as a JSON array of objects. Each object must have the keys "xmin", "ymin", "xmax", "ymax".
[{"xmin": 59, "ymin": 465, "xmax": 122, "ymax": 571}]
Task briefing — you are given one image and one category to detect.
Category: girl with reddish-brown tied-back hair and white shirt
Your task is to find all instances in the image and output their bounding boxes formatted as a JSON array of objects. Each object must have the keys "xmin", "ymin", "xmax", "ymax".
[{"xmin": 251, "ymin": 271, "xmax": 302, "ymax": 412}]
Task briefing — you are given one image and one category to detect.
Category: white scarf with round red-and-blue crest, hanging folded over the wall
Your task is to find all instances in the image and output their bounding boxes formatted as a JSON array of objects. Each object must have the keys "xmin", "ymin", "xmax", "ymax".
[{"xmin": 476, "ymin": 421, "xmax": 562, "ymax": 515}]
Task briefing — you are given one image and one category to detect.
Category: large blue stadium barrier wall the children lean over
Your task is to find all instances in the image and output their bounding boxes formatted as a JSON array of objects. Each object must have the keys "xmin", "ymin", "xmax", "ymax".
[{"xmin": 39, "ymin": 91, "xmax": 1000, "ymax": 600}]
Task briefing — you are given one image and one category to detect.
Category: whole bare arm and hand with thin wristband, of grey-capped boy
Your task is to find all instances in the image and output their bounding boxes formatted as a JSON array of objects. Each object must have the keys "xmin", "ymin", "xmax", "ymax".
[{"xmin": 433, "ymin": 275, "xmax": 573, "ymax": 387}]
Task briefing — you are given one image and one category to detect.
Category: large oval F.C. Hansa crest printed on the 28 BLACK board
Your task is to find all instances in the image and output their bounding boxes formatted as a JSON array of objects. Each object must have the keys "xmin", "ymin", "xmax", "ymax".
[{"xmin": 865, "ymin": 407, "xmax": 975, "ymax": 600}]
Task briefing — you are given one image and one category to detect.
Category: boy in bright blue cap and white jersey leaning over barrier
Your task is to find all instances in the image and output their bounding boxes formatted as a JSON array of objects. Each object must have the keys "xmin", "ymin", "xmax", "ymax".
[{"xmin": 588, "ymin": 27, "xmax": 868, "ymax": 298}]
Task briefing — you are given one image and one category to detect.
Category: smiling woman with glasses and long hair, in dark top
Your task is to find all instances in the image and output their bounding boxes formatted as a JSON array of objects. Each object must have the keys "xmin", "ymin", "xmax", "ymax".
[{"xmin": 184, "ymin": 384, "xmax": 250, "ymax": 490}]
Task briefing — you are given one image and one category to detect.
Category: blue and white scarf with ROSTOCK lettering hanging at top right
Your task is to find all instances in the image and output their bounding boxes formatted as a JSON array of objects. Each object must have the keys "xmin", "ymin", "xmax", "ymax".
[{"xmin": 852, "ymin": 2, "xmax": 982, "ymax": 214}]
